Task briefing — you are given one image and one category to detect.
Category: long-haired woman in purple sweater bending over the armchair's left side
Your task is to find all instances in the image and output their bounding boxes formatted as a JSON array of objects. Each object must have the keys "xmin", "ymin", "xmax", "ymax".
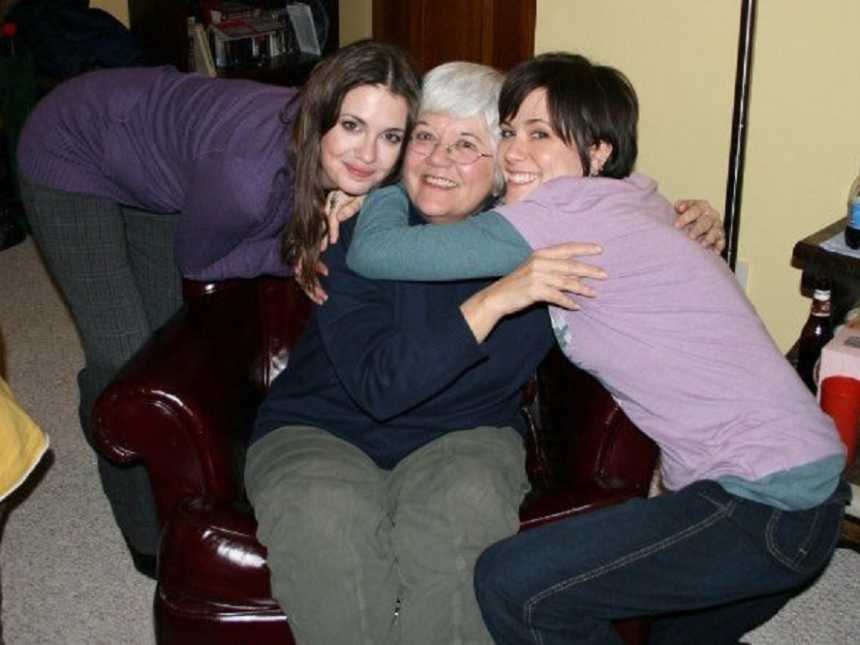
[{"xmin": 18, "ymin": 41, "xmax": 419, "ymax": 572}]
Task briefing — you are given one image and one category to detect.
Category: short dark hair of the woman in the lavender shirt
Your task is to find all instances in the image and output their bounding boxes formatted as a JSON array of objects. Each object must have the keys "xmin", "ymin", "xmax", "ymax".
[{"xmin": 499, "ymin": 52, "xmax": 639, "ymax": 179}]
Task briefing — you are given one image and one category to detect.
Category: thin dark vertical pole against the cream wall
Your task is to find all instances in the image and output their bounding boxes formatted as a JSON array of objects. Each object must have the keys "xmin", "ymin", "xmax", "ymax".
[{"xmin": 723, "ymin": 0, "xmax": 757, "ymax": 271}]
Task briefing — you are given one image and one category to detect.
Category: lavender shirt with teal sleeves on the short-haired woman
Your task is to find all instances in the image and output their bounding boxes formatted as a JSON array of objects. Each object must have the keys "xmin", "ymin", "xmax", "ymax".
[{"xmin": 347, "ymin": 180, "xmax": 845, "ymax": 510}]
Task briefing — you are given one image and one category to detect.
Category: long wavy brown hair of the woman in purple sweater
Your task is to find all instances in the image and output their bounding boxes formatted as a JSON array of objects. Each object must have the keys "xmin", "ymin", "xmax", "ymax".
[{"xmin": 282, "ymin": 40, "xmax": 419, "ymax": 284}]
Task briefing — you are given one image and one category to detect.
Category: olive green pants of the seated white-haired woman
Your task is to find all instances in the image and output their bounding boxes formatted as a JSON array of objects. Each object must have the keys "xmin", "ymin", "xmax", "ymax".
[{"xmin": 245, "ymin": 426, "xmax": 528, "ymax": 645}]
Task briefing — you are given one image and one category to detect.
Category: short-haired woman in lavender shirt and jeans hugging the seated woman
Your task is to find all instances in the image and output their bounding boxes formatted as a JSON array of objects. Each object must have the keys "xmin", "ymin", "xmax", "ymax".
[{"xmin": 347, "ymin": 53, "xmax": 850, "ymax": 645}]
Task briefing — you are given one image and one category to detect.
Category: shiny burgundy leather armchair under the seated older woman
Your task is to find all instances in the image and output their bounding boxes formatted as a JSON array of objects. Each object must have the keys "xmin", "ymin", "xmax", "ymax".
[{"xmin": 96, "ymin": 278, "xmax": 657, "ymax": 645}]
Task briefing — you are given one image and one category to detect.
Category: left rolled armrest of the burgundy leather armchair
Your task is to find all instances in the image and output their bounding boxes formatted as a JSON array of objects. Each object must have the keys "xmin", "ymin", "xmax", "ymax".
[{"xmin": 94, "ymin": 280, "xmax": 262, "ymax": 523}]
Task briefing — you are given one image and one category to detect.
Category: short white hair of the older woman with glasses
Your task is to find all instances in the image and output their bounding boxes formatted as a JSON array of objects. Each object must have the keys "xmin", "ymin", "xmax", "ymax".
[{"xmin": 418, "ymin": 61, "xmax": 505, "ymax": 194}]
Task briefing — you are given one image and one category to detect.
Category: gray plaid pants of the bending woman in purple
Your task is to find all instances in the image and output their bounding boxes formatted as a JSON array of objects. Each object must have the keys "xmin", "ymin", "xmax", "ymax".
[{"xmin": 21, "ymin": 180, "xmax": 182, "ymax": 555}]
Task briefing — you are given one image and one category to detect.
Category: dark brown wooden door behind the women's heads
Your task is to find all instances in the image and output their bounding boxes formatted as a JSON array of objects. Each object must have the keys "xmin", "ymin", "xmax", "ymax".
[{"xmin": 373, "ymin": 0, "xmax": 535, "ymax": 73}]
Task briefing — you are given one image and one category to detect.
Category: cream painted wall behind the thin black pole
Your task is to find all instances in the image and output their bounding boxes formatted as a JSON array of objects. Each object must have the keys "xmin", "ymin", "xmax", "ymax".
[{"xmin": 535, "ymin": 0, "xmax": 860, "ymax": 350}]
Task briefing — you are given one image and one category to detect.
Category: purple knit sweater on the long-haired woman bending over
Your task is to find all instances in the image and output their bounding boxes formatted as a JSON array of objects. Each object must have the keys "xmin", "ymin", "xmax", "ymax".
[{"xmin": 18, "ymin": 67, "xmax": 296, "ymax": 280}]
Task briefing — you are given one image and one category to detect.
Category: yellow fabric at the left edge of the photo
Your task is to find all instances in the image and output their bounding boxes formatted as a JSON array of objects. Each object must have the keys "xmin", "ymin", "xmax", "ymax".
[{"xmin": 0, "ymin": 378, "xmax": 48, "ymax": 501}]
